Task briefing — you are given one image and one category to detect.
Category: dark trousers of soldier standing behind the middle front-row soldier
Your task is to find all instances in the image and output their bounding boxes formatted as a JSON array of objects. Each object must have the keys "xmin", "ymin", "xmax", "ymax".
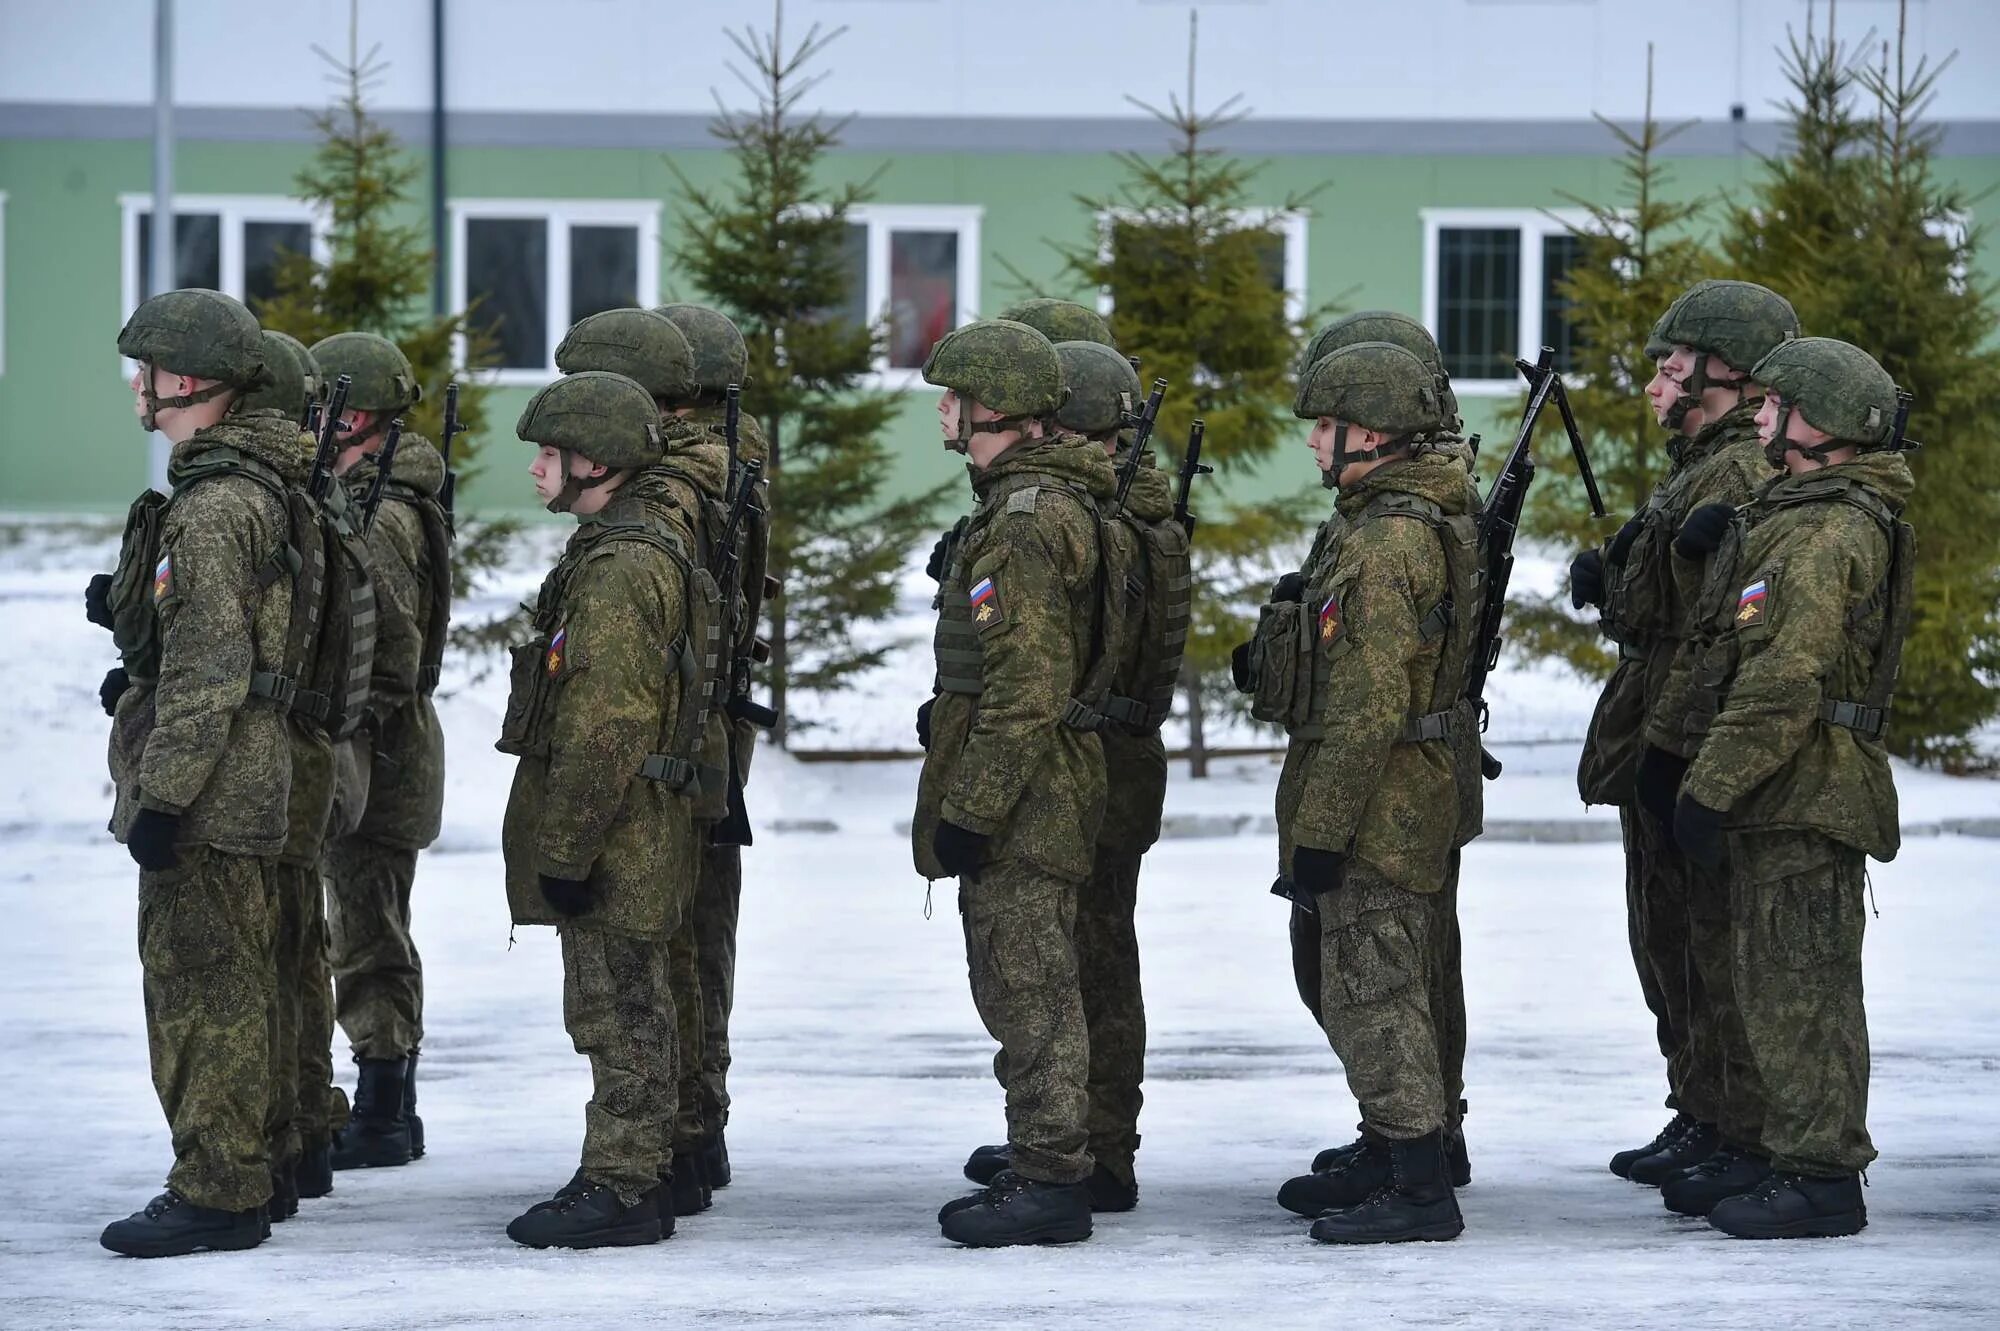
[{"xmin": 1076, "ymin": 845, "xmax": 1146, "ymax": 1183}]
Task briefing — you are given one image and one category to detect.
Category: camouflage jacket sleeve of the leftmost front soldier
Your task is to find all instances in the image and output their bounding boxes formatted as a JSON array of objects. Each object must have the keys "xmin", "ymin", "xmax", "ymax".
[{"xmin": 138, "ymin": 478, "xmax": 290, "ymax": 813}]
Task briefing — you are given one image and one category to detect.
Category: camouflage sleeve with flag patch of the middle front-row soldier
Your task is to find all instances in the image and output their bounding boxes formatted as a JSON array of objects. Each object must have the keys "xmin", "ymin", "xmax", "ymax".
[{"xmin": 944, "ymin": 500, "xmax": 1096, "ymax": 833}]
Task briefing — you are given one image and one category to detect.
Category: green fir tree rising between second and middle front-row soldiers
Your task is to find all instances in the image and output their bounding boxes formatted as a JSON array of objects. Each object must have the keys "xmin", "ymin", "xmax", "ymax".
[{"xmin": 668, "ymin": 0, "xmax": 944, "ymax": 745}]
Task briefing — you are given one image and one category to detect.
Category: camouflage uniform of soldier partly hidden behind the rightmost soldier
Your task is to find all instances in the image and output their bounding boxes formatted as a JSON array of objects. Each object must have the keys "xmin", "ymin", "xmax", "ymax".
[{"xmin": 1578, "ymin": 396, "xmax": 1770, "ymax": 1145}]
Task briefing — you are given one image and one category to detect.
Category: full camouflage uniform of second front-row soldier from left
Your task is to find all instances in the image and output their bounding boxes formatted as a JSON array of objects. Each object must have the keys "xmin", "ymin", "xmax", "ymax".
[{"xmin": 498, "ymin": 465, "xmax": 700, "ymax": 1205}]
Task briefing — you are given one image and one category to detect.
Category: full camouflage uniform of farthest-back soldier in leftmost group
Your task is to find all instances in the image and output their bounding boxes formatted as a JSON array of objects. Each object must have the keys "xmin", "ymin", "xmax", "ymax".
[{"xmin": 326, "ymin": 432, "xmax": 452, "ymax": 1059}]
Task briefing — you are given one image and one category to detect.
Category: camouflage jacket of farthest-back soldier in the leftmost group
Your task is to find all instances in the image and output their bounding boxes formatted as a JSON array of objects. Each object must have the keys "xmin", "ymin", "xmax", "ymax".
[{"xmin": 340, "ymin": 434, "xmax": 452, "ymax": 849}]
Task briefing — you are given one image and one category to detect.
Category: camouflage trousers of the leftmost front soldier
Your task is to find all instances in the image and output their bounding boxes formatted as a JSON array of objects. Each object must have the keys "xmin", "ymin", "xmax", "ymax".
[{"xmin": 138, "ymin": 845, "xmax": 278, "ymax": 1211}]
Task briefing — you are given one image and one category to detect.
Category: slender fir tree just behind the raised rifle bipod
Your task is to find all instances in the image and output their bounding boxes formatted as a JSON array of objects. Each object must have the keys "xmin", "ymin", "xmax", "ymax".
[{"xmin": 1508, "ymin": 46, "xmax": 1718, "ymax": 677}]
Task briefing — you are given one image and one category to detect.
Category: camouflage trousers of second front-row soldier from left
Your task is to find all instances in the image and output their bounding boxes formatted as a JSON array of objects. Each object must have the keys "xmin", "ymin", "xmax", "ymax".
[{"xmin": 560, "ymin": 923, "xmax": 676, "ymax": 1205}]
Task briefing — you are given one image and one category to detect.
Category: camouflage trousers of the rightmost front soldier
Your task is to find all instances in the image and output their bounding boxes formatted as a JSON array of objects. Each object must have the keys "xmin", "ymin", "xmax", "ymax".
[{"xmin": 1728, "ymin": 831, "xmax": 1876, "ymax": 1175}]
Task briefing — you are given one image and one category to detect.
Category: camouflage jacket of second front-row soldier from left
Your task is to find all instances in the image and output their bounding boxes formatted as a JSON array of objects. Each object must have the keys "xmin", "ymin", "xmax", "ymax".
[{"xmin": 496, "ymin": 472, "xmax": 698, "ymax": 937}]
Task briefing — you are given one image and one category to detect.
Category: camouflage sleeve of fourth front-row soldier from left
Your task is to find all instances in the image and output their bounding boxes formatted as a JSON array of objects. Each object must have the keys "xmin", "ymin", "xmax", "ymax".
[{"xmin": 1292, "ymin": 518, "xmax": 1444, "ymax": 851}]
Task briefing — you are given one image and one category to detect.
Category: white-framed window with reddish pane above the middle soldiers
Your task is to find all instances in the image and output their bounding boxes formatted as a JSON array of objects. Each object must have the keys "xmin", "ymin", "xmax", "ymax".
[{"xmin": 840, "ymin": 204, "xmax": 982, "ymax": 388}]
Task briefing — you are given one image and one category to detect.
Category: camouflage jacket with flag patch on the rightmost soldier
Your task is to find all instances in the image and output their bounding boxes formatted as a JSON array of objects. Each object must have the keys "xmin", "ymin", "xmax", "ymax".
[{"xmin": 1670, "ymin": 454, "xmax": 1916, "ymax": 859}]
